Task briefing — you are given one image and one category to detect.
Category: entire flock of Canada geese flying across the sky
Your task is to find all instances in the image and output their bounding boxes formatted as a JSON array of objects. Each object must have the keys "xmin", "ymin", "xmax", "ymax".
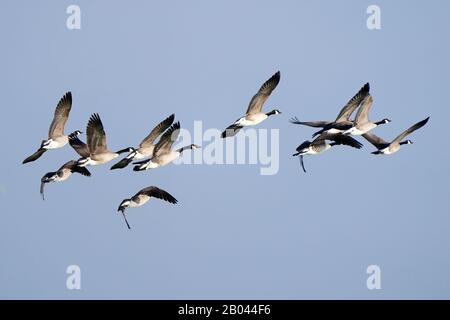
[{"xmin": 23, "ymin": 71, "xmax": 429, "ymax": 229}]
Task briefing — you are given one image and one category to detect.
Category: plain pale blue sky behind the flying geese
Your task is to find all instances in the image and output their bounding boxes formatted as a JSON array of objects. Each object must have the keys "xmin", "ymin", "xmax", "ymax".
[{"xmin": 0, "ymin": 0, "xmax": 450, "ymax": 299}]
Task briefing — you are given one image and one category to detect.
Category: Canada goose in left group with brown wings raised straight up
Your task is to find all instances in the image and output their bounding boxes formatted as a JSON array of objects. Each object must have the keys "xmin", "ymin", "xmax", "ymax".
[{"xmin": 75, "ymin": 113, "xmax": 133, "ymax": 167}]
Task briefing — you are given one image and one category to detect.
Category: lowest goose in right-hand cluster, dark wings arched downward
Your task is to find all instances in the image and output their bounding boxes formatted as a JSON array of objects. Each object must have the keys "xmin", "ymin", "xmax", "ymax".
[{"xmin": 293, "ymin": 132, "xmax": 362, "ymax": 172}]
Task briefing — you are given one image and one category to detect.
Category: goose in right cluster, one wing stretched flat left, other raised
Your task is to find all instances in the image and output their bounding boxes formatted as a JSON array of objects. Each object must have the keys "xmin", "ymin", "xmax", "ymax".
[{"xmin": 290, "ymin": 83, "xmax": 370, "ymax": 137}]
